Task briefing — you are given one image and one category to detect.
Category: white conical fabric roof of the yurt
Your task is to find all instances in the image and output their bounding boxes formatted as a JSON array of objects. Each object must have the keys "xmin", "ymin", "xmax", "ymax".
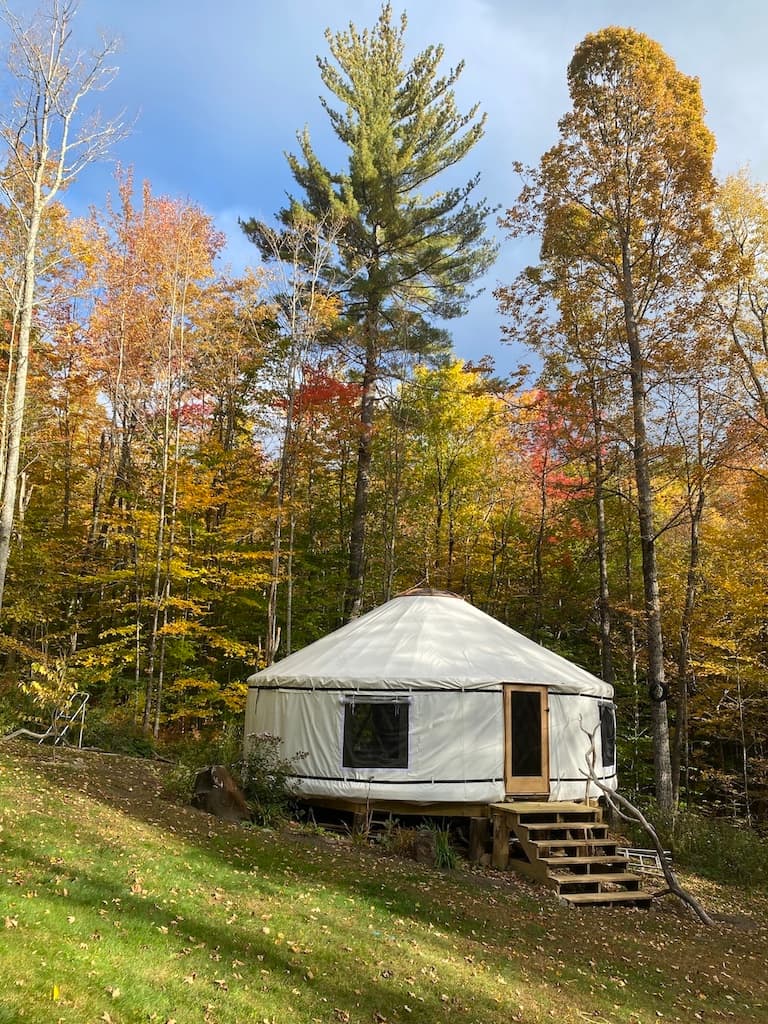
[{"xmin": 248, "ymin": 592, "xmax": 612, "ymax": 697}]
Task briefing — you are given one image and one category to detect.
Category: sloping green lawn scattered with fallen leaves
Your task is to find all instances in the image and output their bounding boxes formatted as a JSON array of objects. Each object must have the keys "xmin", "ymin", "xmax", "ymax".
[{"xmin": 0, "ymin": 741, "xmax": 768, "ymax": 1024}]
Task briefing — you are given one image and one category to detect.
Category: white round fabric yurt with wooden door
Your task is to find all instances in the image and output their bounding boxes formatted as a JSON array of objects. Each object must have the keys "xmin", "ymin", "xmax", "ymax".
[{"xmin": 245, "ymin": 591, "xmax": 616, "ymax": 815}]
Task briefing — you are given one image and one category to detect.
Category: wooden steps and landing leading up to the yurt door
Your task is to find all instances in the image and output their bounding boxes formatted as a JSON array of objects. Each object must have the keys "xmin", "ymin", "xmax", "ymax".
[{"xmin": 490, "ymin": 801, "xmax": 652, "ymax": 906}]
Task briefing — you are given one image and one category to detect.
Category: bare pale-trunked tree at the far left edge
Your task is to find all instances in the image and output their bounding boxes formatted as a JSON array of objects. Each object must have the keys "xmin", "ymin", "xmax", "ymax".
[{"xmin": 0, "ymin": 0, "xmax": 124, "ymax": 607}]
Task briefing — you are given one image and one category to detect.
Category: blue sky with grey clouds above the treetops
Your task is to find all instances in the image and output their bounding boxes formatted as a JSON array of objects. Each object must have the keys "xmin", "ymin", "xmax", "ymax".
[{"xmin": 3, "ymin": 0, "xmax": 768, "ymax": 370}]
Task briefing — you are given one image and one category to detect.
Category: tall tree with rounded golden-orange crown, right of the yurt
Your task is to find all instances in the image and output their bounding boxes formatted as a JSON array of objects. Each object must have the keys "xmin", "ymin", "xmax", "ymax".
[{"xmin": 507, "ymin": 28, "xmax": 715, "ymax": 807}]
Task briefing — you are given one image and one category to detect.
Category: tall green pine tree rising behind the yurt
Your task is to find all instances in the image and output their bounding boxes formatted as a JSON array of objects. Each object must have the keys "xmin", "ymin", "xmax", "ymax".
[{"xmin": 245, "ymin": 3, "xmax": 496, "ymax": 617}]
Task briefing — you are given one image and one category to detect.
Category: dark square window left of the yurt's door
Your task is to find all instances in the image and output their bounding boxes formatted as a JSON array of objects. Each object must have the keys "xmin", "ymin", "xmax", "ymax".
[{"xmin": 342, "ymin": 694, "xmax": 410, "ymax": 768}]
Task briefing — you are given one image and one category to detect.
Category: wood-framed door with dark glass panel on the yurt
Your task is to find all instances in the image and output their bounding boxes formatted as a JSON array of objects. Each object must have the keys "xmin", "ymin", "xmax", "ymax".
[{"xmin": 504, "ymin": 684, "xmax": 549, "ymax": 797}]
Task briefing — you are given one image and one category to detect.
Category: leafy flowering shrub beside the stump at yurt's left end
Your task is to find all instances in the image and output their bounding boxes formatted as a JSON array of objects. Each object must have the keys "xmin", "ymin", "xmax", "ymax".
[{"xmin": 233, "ymin": 732, "xmax": 306, "ymax": 826}]
